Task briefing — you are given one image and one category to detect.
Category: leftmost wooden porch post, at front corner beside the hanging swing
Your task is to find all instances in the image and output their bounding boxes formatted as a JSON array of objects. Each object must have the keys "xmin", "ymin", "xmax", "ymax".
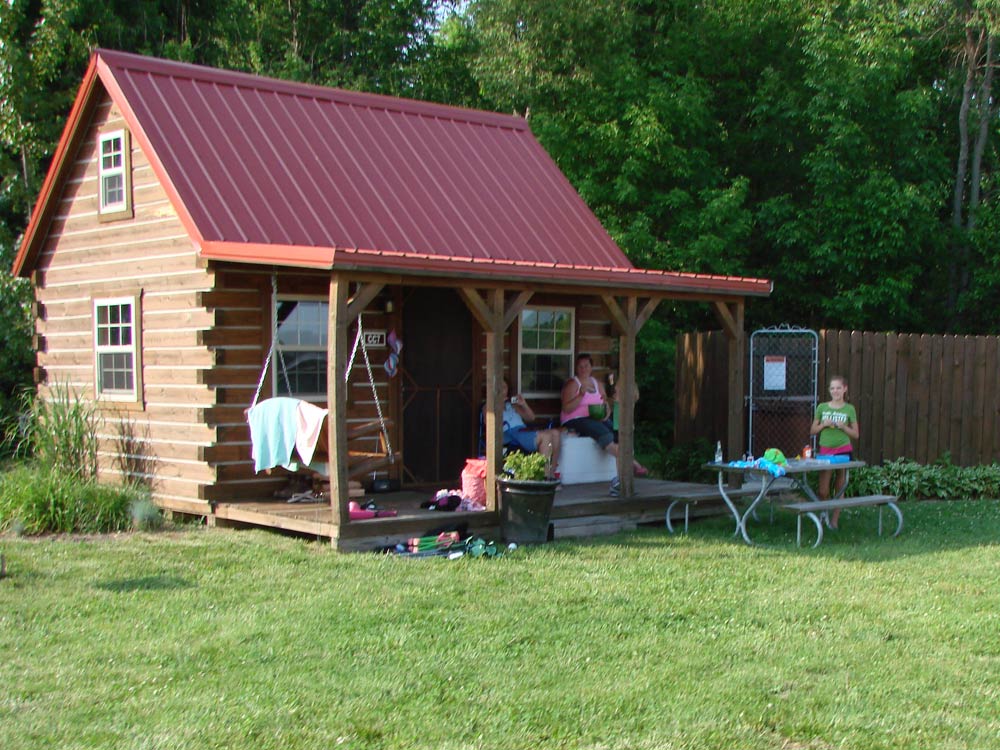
[{"xmin": 326, "ymin": 272, "xmax": 352, "ymax": 546}]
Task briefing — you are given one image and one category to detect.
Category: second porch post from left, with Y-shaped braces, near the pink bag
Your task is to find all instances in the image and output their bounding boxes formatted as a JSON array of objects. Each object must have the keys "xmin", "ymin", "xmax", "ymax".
[{"xmin": 458, "ymin": 287, "xmax": 532, "ymax": 510}]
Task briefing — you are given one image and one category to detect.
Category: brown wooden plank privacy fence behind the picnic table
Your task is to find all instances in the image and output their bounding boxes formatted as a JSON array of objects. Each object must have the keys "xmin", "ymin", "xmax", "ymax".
[{"xmin": 674, "ymin": 331, "xmax": 1000, "ymax": 466}]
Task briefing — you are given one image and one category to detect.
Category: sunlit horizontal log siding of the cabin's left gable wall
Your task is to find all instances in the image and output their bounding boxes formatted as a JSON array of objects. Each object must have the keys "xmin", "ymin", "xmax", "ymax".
[{"xmin": 36, "ymin": 95, "xmax": 215, "ymax": 512}]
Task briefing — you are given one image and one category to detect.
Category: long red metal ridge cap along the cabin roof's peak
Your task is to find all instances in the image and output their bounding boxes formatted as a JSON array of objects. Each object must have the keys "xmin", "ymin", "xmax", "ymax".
[{"xmin": 94, "ymin": 48, "xmax": 528, "ymax": 130}]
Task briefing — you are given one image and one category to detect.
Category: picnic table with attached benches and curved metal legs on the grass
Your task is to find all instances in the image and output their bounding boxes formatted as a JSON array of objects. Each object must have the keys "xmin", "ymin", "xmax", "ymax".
[{"xmin": 696, "ymin": 458, "xmax": 903, "ymax": 546}]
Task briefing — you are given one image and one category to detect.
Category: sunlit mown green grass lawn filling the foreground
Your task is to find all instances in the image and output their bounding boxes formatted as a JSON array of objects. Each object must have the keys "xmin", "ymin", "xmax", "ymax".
[{"xmin": 0, "ymin": 502, "xmax": 1000, "ymax": 750}]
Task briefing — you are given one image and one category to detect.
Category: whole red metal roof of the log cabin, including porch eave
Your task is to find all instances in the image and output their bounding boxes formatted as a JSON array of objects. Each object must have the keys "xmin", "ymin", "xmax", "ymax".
[{"xmin": 9, "ymin": 50, "xmax": 771, "ymax": 295}]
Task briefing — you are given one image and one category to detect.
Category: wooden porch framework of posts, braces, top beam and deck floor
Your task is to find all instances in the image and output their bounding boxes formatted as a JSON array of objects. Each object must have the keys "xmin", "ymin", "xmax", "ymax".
[{"xmin": 310, "ymin": 268, "xmax": 760, "ymax": 550}]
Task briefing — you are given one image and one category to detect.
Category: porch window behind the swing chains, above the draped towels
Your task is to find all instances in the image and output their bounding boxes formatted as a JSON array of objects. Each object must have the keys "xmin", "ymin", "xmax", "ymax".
[{"xmin": 271, "ymin": 296, "xmax": 330, "ymax": 401}]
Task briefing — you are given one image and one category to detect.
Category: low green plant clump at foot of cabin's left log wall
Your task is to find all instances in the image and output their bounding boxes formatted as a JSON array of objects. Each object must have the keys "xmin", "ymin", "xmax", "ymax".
[{"xmin": 0, "ymin": 464, "xmax": 141, "ymax": 534}]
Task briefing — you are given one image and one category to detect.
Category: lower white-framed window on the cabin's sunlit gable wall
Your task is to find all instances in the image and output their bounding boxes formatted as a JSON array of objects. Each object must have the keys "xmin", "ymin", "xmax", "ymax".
[{"xmin": 94, "ymin": 297, "xmax": 139, "ymax": 401}]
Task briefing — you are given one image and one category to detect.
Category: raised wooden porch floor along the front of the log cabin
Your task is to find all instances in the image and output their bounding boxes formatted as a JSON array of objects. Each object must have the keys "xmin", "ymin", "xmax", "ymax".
[{"xmin": 212, "ymin": 478, "xmax": 756, "ymax": 552}]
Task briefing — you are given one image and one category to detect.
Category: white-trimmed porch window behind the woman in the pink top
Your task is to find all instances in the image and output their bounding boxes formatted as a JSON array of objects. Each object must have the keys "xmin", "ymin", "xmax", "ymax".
[{"xmin": 518, "ymin": 307, "xmax": 575, "ymax": 397}]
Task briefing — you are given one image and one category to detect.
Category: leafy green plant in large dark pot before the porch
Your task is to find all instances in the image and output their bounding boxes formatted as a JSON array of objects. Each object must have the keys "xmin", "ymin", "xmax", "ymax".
[{"xmin": 497, "ymin": 452, "xmax": 559, "ymax": 544}]
